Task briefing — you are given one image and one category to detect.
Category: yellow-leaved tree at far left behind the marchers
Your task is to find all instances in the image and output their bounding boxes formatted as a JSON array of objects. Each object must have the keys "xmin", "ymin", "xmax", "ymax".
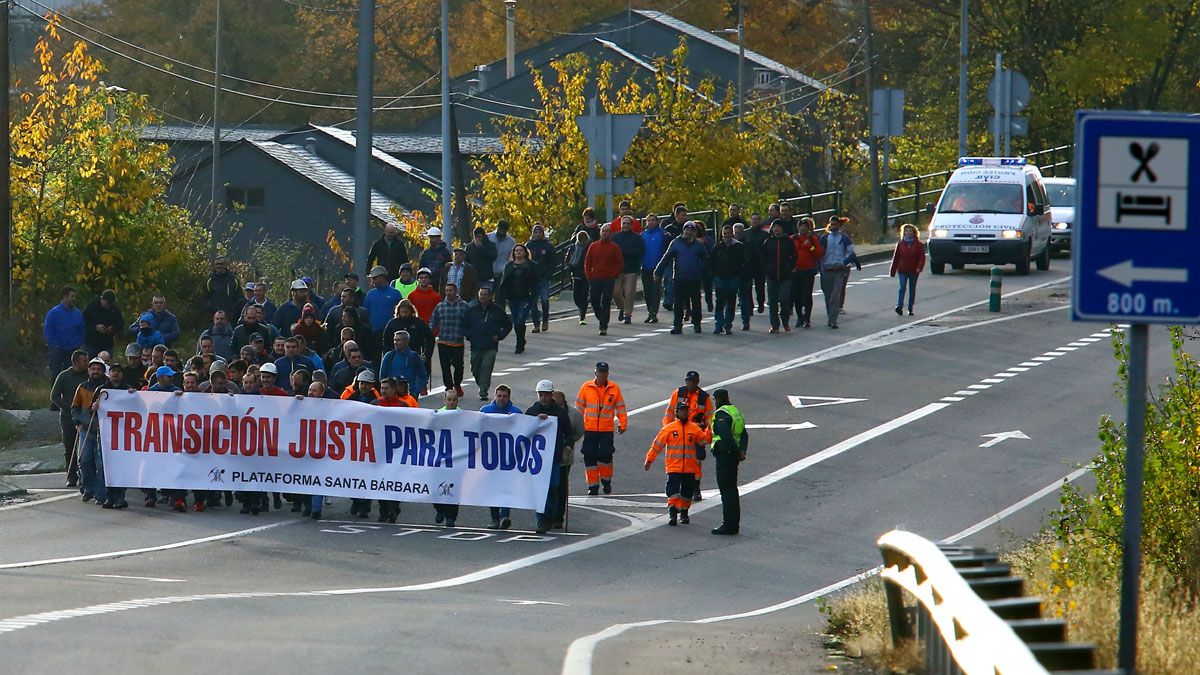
[{"xmin": 10, "ymin": 17, "xmax": 209, "ymax": 340}]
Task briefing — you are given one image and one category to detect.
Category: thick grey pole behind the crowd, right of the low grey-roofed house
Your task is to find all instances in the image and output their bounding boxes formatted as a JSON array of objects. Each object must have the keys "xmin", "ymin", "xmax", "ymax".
[{"xmin": 350, "ymin": 0, "xmax": 374, "ymax": 279}]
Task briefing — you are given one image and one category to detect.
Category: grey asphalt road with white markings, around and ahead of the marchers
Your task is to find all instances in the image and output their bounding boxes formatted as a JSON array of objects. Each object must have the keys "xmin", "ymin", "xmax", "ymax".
[{"xmin": 0, "ymin": 261, "xmax": 1168, "ymax": 673}]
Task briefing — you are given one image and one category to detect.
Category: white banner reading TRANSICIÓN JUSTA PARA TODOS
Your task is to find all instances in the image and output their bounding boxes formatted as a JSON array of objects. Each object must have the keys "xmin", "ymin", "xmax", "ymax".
[{"xmin": 100, "ymin": 390, "xmax": 558, "ymax": 510}]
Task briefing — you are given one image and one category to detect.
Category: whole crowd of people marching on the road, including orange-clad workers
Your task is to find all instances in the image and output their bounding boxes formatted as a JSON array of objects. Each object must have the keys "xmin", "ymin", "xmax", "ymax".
[{"xmin": 43, "ymin": 202, "xmax": 924, "ymax": 534}]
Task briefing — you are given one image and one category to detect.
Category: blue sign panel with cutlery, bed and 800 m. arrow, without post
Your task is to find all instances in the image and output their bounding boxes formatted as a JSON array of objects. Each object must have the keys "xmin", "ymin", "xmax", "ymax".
[{"xmin": 1072, "ymin": 110, "xmax": 1200, "ymax": 324}]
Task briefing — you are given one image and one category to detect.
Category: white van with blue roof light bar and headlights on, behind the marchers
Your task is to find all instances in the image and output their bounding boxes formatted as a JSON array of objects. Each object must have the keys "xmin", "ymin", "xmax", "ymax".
[{"xmin": 929, "ymin": 157, "xmax": 1051, "ymax": 274}]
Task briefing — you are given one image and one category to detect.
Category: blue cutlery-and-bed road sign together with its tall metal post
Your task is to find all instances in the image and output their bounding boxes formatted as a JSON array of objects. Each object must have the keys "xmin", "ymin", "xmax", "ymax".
[{"xmin": 1072, "ymin": 110, "xmax": 1200, "ymax": 673}]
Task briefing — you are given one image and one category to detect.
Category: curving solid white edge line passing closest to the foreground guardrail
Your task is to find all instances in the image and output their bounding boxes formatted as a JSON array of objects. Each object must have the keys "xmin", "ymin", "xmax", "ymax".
[{"xmin": 562, "ymin": 467, "xmax": 1091, "ymax": 675}]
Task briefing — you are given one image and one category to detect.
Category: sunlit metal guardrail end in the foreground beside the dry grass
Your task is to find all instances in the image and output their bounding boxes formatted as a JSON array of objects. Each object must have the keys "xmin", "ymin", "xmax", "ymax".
[{"xmin": 877, "ymin": 530, "xmax": 1121, "ymax": 675}]
